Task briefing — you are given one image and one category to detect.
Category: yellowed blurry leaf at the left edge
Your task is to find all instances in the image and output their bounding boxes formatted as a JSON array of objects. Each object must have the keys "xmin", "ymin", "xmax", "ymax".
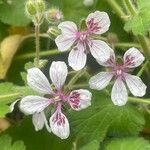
[{"xmin": 0, "ymin": 35, "xmax": 22, "ymax": 79}]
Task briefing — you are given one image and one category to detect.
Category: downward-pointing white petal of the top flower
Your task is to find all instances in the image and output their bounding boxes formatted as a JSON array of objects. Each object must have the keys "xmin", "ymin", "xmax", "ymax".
[{"xmin": 68, "ymin": 43, "xmax": 87, "ymax": 71}]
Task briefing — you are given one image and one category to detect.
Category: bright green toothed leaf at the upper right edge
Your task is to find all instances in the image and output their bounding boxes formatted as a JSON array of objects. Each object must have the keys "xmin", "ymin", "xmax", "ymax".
[{"xmin": 124, "ymin": 8, "xmax": 150, "ymax": 35}]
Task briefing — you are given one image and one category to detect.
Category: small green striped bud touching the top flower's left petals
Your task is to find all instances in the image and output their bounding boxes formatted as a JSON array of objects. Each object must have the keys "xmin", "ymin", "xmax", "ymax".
[{"xmin": 47, "ymin": 27, "xmax": 60, "ymax": 39}]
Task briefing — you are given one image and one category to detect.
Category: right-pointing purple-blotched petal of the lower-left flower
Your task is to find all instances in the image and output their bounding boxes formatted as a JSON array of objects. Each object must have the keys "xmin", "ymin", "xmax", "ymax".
[{"xmin": 69, "ymin": 89, "xmax": 92, "ymax": 111}]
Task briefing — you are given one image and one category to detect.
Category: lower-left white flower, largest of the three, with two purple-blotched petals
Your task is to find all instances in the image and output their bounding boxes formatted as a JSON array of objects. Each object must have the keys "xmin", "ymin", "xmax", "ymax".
[{"xmin": 20, "ymin": 61, "xmax": 92, "ymax": 139}]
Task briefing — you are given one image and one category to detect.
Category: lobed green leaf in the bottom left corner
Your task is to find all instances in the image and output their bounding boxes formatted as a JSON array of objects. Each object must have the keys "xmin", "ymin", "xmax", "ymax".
[{"xmin": 0, "ymin": 135, "xmax": 26, "ymax": 150}]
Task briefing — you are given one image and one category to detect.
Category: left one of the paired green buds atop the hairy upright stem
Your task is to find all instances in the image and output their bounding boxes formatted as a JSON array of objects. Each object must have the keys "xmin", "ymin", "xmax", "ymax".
[{"xmin": 25, "ymin": 0, "xmax": 37, "ymax": 16}]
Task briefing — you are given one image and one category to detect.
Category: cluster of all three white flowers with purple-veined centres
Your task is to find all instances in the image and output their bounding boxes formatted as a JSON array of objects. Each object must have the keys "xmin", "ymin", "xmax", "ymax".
[{"xmin": 13, "ymin": 11, "xmax": 146, "ymax": 139}]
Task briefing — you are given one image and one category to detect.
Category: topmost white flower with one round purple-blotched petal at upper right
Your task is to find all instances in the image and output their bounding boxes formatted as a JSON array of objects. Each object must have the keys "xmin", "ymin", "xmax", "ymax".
[{"xmin": 55, "ymin": 11, "xmax": 110, "ymax": 70}]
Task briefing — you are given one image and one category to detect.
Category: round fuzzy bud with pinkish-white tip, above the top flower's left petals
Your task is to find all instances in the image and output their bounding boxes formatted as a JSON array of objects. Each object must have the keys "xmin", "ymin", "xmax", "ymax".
[{"xmin": 45, "ymin": 8, "xmax": 63, "ymax": 24}]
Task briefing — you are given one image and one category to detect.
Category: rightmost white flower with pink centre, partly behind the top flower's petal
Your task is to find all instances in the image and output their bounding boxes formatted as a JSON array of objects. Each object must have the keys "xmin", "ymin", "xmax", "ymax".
[{"xmin": 89, "ymin": 48, "xmax": 147, "ymax": 106}]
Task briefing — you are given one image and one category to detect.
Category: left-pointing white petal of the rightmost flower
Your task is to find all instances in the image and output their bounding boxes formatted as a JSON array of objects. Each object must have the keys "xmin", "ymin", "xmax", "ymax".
[{"xmin": 89, "ymin": 72, "xmax": 113, "ymax": 90}]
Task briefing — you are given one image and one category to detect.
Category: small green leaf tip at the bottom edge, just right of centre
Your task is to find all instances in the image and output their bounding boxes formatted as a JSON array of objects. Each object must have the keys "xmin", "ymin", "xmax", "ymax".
[{"xmin": 79, "ymin": 140, "xmax": 99, "ymax": 150}]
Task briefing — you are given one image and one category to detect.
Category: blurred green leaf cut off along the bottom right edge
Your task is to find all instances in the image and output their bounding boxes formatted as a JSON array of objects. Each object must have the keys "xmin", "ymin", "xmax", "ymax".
[{"xmin": 104, "ymin": 137, "xmax": 150, "ymax": 150}]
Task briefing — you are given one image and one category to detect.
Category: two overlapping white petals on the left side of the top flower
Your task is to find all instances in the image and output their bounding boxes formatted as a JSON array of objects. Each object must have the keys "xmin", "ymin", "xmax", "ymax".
[{"xmin": 55, "ymin": 21, "xmax": 78, "ymax": 51}]
